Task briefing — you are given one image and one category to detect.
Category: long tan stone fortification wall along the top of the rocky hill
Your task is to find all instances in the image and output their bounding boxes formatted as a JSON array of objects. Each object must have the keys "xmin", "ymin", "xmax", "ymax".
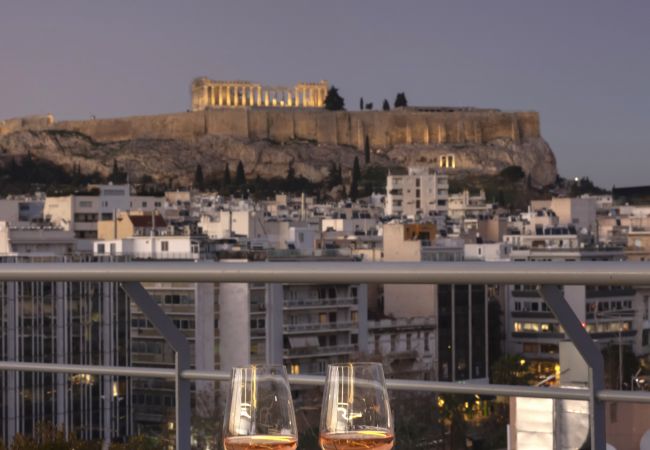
[{"xmin": 0, "ymin": 108, "xmax": 540, "ymax": 148}]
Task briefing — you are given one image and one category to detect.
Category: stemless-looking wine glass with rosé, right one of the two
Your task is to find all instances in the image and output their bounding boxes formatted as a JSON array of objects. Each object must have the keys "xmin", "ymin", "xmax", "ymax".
[{"xmin": 320, "ymin": 363, "xmax": 395, "ymax": 450}]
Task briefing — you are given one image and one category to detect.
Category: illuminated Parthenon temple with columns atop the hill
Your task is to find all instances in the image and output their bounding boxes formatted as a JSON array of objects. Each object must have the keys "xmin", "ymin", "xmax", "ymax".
[{"xmin": 192, "ymin": 77, "xmax": 328, "ymax": 111}]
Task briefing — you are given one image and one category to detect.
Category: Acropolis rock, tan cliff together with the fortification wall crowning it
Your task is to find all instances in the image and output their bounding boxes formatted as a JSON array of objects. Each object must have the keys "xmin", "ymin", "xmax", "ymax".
[{"xmin": 0, "ymin": 108, "xmax": 557, "ymax": 186}]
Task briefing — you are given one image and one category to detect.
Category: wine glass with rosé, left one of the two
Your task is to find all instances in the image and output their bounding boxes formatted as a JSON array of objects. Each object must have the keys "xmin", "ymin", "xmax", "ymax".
[{"xmin": 223, "ymin": 365, "xmax": 298, "ymax": 450}]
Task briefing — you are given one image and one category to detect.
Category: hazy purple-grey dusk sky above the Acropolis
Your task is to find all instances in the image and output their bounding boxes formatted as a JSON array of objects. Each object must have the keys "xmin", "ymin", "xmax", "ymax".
[{"xmin": 0, "ymin": 0, "xmax": 650, "ymax": 188}]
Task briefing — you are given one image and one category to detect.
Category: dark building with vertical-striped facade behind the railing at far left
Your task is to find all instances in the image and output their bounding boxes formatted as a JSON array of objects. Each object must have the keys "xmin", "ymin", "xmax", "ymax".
[{"xmin": 0, "ymin": 256, "xmax": 132, "ymax": 442}]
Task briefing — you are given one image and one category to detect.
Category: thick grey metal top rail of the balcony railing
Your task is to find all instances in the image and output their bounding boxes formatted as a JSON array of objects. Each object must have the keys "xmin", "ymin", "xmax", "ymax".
[{"xmin": 0, "ymin": 261, "xmax": 650, "ymax": 286}]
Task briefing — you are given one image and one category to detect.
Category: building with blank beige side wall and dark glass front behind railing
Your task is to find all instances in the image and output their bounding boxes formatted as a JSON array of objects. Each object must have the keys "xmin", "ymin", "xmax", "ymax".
[{"xmin": 383, "ymin": 224, "xmax": 488, "ymax": 381}]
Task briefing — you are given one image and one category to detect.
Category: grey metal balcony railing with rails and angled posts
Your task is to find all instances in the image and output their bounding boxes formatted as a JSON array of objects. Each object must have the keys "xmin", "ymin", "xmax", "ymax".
[{"xmin": 0, "ymin": 262, "xmax": 650, "ymax": 450}]
